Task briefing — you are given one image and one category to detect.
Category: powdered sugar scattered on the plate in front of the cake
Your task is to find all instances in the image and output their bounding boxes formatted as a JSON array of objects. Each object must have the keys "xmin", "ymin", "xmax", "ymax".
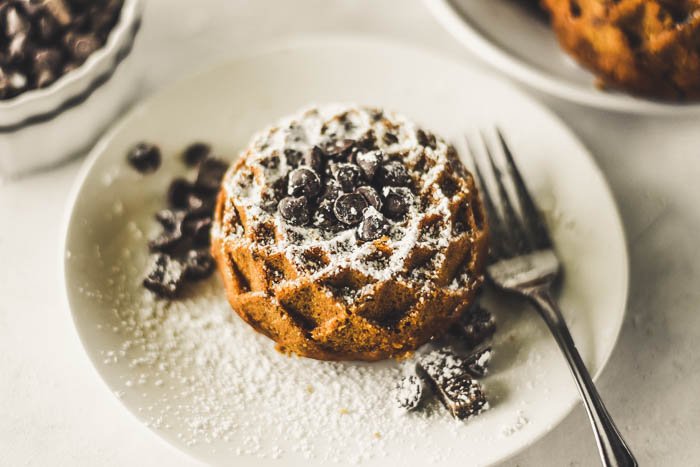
[{"xmin": 68, "ymin": 209, "xmax": 504, "ymax": 463}]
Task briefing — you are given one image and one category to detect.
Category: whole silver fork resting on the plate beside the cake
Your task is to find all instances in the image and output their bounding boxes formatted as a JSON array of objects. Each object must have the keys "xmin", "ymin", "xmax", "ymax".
[{"xmin": 467, "ymin": 130, "xmax": 637, "ymax": 467}]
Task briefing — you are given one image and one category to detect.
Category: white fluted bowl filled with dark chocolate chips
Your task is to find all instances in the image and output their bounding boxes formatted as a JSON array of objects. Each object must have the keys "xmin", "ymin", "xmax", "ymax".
[{"xmin": 0, "ymin": 0, "xmax": 142, "ymax": 177}]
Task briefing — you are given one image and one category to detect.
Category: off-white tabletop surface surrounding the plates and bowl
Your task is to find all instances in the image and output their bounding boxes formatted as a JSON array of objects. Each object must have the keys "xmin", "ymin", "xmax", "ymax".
[{"xmin": 0, "ymin": 0, "xmax": 700, "ymax": 466}]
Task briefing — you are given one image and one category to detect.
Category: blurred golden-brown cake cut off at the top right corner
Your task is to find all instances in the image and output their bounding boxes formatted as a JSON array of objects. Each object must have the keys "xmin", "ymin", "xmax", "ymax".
[{"xmin": 541, "ymin": 0, "xmax": 700, "ymax": 100}]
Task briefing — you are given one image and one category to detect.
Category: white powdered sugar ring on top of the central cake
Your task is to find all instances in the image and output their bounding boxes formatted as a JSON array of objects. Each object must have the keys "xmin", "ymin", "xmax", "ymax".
[{"xmin": 213, "ymin": 105, "xmax": 467, "ymax": 288}]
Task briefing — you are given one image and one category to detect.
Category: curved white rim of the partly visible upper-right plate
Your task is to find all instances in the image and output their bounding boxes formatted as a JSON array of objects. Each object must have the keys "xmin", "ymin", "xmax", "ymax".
[{"xmin": 423, "ymin": 0, "xmax": 700, "ymax": 117}]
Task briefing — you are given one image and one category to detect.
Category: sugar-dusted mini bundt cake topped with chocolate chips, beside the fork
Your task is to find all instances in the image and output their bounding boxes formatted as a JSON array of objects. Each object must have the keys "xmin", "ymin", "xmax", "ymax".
[{"xmin": 212, "ymin": 107, "xmax": 486, "ymax": 360}]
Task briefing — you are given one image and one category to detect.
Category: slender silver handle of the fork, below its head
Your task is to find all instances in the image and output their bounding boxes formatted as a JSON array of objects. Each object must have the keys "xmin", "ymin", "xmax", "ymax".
[{"xmin": 527, "ymin": 286, "xmax": 637, "ymax": 467}]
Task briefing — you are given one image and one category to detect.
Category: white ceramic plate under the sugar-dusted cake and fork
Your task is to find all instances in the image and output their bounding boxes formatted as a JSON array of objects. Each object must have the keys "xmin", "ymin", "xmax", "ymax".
[{"xmin": 65, "ymin": 38, "xmax": 627, "ymax": 466}]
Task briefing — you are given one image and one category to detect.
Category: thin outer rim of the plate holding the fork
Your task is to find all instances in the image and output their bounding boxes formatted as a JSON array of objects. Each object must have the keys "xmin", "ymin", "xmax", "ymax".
[{"xmin": 58, "ymin": 34, "xmax": 630, "ymax": 465}]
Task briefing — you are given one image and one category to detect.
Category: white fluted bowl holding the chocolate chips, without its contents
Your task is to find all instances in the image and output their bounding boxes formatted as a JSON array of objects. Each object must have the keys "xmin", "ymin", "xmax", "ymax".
[{"xmin": 0, "ymin": 0, "xmax": 142, "ymax": 178}]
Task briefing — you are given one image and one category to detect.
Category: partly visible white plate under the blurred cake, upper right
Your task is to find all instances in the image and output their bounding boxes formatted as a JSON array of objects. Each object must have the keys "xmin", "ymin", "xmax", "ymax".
[{"xmin": 425, "ymin": 0, "xmax": 700, "ymax": 115}]
